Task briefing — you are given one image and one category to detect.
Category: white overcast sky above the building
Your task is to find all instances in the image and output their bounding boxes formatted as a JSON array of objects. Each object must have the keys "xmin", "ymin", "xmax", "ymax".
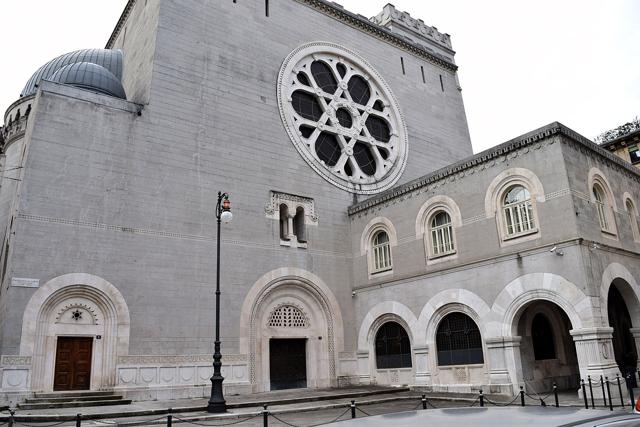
[{"xmin": 0, "ymin": 0, "xmax": 640, "ymax": 152}]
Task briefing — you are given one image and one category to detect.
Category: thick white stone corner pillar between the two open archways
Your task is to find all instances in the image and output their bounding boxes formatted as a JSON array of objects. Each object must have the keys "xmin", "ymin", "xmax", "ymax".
[{"xmin": 569, "ymin": 326, "xmax": 620, "ymax": 398}]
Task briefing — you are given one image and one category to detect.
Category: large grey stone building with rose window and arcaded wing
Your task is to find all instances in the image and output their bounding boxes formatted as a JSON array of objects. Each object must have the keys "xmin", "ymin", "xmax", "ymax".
[{"xmin": 0, "ymin": 0, "xmax": 640, "ymax": 401}]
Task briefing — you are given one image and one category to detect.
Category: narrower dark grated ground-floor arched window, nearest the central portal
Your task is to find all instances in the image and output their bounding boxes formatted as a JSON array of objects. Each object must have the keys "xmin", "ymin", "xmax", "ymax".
[{"xmin": 376, "ymin": 322, "xmax": 411, "ymax": 369}]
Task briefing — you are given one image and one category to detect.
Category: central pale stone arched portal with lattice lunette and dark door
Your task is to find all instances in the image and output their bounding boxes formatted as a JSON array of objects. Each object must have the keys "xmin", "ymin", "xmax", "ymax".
[{"xmin": 240, "ymin": 268, "xmax": 343, "ymax": 392}]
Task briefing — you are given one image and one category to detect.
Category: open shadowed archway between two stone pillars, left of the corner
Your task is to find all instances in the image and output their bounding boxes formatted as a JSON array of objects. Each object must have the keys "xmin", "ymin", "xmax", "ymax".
[{"xmin": 516, "ymin": 300, "xmax": 580, "ymax": 393}]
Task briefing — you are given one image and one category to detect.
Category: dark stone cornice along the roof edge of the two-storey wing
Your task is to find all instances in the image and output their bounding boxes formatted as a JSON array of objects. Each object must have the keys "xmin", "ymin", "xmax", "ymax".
[{"xmin": 348, "ymin": 122, "xmax": 640, "ymax": 215}]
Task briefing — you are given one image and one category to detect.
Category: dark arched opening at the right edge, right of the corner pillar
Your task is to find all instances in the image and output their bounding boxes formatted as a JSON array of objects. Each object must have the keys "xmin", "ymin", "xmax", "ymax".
[{"xmin": 607, "ymin": 278, "xmax": 638, "ymax": 387}]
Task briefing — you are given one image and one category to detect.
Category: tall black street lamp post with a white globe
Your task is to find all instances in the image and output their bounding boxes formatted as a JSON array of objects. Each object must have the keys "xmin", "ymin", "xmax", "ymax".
[{"xmin": 207, "ymin": 191, "xmax": 233, "ymax": 413}]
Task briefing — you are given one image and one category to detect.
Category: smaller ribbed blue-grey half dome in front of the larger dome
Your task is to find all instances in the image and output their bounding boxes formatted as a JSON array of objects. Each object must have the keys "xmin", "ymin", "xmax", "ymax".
[{"xmin": 47, "ymin": 62, "xmax": 127, "ymax": 99}]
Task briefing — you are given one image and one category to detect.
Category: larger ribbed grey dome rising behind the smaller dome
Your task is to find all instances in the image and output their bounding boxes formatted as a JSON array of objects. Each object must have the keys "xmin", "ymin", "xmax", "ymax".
[{"xmin": 20, "ymin": 49, "xmax": 124, "ymax": 97}]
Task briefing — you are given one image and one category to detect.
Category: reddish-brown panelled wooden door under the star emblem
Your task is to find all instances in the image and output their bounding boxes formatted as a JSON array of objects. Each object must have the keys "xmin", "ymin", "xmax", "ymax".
[{"xmin": 53, "ymin": 337, "xmax": 93, "ymax": 391}]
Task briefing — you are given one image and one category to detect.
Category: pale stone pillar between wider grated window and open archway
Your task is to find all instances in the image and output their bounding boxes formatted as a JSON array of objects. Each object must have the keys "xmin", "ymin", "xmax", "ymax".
[{"xmin": 485, "ymin": 336, "xmax": 522, "ymax": 394}]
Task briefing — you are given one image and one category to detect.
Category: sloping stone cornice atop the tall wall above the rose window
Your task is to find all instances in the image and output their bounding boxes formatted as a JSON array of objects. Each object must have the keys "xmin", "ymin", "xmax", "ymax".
[{"xmin": 295, "ymin": 0, "xmax": 458, "ymax": 72}]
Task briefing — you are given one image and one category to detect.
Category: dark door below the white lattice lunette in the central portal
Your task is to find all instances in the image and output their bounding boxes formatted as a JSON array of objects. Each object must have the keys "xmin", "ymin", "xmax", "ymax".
[{"xmin": 269, "ymin": 338, "xmax": 307, "ymax": 390}]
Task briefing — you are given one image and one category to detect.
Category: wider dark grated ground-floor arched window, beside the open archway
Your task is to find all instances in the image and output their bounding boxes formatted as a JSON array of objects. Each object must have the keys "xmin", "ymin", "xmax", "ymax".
[{"xmin": 436, "ymin": 313, "xmax": 484, "ymax": 366}]
